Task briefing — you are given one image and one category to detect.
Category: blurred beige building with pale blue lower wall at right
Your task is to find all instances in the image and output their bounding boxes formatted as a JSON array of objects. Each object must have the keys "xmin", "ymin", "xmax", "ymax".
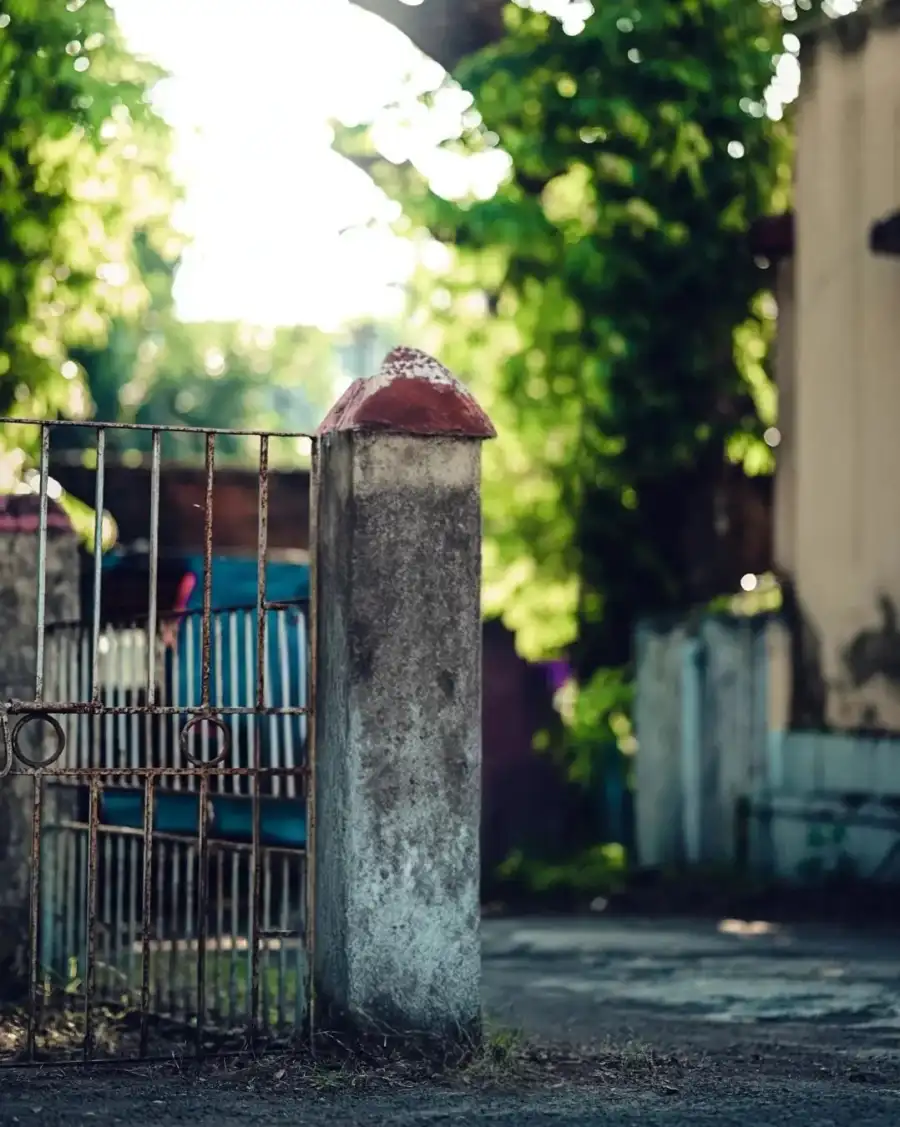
[{"xmin": 635, "ymin": 0, "xmax": 900, "ymax": 886}]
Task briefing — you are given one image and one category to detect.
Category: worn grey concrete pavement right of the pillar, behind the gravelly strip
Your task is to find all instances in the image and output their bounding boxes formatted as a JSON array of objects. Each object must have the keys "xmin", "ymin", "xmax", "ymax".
[{"xmin": 483, "ymin": 917, "xmax": 900, "ymax": 1050}]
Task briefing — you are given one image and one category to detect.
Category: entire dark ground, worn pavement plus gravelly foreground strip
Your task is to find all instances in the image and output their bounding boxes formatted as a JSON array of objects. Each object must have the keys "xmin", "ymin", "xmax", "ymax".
[{"xmin": 0, "ymin": 919, "xmax": 900, "ymax": 1127}]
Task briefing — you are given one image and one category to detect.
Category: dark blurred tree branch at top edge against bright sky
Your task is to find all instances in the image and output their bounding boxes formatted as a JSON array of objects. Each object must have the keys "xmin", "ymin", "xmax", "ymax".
[{"xmin": 353, "ymin": 0, "xmax": 507, "ymax": 71}]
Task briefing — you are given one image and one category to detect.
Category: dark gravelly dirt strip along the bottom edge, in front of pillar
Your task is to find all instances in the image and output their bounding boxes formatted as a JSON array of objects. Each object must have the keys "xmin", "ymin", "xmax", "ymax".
[{"xmin": 0, "ymin": 1041, "xmax": 900, "ymax": 1127}]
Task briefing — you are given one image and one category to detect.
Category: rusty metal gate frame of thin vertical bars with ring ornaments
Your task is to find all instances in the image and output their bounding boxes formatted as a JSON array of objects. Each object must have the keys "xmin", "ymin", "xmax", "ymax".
[{"xmin": 0, "ymin": 418, "xmax": 318, "ymax": 1066}]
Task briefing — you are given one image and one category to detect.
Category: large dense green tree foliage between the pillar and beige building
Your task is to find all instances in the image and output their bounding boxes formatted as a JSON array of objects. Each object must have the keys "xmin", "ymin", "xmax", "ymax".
[{"xmin": 338, "ymin": 0, "xmax": 790, "ymax": 680}]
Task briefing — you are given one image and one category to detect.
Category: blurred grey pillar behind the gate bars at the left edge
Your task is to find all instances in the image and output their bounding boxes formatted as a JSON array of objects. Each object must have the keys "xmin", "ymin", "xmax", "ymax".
[{"xmin": 0, "ymin": 494, "xmax": 79, "ymax": 1001}]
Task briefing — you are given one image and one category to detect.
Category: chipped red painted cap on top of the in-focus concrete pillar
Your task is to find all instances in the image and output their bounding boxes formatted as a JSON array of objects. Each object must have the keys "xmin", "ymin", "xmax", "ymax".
[{"xmin": 317, "ymin": 348, "xmax": 497, "ymax": 438}]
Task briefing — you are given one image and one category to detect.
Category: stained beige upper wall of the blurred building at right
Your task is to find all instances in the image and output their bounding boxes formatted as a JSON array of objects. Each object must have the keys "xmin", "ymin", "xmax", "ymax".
[{"xmin": 792, "ymin": 28, "xmax": 900, "ymax": 730}]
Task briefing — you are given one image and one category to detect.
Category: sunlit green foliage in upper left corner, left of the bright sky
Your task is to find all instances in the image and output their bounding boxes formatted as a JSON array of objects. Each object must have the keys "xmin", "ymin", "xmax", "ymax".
[{"xmin": 0, "ymin": 0, "xmax": 182, "ymax": 471}]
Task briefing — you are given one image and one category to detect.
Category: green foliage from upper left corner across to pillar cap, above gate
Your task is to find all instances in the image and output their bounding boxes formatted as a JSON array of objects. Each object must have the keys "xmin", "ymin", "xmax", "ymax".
[{"xmin": 0, "ymin": 0, "xmax": 333, "ymax": 469}]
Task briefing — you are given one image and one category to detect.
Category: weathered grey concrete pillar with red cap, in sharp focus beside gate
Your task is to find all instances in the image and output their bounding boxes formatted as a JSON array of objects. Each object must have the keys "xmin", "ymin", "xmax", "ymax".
[{"xmin": 313, "ymin": 348, "xmax": 494, "ymax": 1046}]
